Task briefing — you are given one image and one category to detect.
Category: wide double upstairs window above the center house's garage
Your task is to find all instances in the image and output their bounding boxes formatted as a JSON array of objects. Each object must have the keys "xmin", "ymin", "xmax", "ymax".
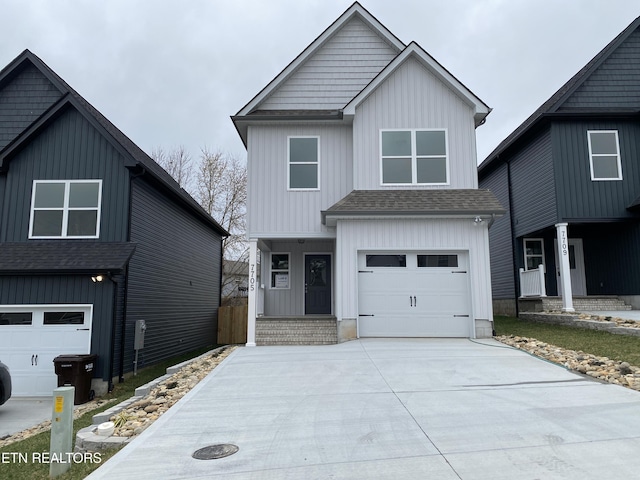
[{"xmin": 380, "ymin": 129, "xmax": 449, "ymax": 185}]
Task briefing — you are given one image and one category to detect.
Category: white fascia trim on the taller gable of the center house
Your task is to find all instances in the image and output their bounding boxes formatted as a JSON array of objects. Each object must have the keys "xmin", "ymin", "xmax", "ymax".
[{"xmin": 236, "ymin": 2, "xmax": 405, "ymax": 116}]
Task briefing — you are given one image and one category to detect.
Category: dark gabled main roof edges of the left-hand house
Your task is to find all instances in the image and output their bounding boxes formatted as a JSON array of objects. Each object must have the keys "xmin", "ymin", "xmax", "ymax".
[{"xmin": 0, "ymin": 50, "xmax": 229, "ymax": 236}]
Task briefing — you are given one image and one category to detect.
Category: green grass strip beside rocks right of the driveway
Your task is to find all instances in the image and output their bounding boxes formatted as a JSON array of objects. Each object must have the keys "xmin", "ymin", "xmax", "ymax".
[{"xmin": 494, "ymin": 317, "xmax": 640, "ymax": 367}]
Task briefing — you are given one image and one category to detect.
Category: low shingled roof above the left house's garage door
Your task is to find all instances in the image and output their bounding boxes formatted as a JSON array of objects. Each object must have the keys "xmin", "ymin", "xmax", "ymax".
[{"xmin": 0, "ymin": 240, "xmax": 136, "ymax": 275}]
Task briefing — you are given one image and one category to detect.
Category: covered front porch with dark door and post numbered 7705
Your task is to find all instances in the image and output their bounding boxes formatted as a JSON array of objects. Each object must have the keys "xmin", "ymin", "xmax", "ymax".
[{"xmin": 247, "ymin": 237, "xmax": 338, "ymax": 346}]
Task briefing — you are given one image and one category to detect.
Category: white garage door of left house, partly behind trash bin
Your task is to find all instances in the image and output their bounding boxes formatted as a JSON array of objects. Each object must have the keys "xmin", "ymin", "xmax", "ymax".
[{"xmin": 0, "ymin": 305, "xmax": 93, "ymax": 397}]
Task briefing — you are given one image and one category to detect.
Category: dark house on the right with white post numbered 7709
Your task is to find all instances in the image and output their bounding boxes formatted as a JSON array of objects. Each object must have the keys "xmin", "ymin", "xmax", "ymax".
[{"xmin": 479, "ymin": 18, "xmax": 640, "ymax": 313}]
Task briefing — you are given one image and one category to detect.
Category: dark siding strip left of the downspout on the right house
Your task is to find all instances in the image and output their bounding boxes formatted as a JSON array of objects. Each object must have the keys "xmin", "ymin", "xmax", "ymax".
[{"xmin": 480, "ymin": 163, "xmax": 516, "ymax": 299}]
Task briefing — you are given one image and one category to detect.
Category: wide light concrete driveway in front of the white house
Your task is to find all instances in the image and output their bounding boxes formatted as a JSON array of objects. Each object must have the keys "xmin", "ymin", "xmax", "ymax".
[{"xmin": 88, "ymin": 339, "xmax": 640, "ymax": 480}]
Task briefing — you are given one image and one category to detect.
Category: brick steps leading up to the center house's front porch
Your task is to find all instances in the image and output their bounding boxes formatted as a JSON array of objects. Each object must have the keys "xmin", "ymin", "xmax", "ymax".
[{"xmin": 256, "ymin": 316, "xmax": 338, "ymax": 345}]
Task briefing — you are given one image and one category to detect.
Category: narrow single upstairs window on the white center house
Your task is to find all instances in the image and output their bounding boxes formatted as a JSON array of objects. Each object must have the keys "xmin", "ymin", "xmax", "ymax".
[{"xmin": 287, "ymin": 136, "xmax": 320, "ymax": 190}]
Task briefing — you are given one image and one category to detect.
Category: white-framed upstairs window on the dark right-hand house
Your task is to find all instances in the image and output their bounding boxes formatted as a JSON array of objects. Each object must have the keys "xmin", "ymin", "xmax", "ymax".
[{"xmin": 587, "ymin": 130, "xmax": 622, "ymax": 180}]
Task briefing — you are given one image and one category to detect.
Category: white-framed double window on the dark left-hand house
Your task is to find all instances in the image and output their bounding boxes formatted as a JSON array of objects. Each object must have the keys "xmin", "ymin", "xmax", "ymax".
[{"xmin": 29, "ymin": 180, "xmax": 102, "ymax": 238}]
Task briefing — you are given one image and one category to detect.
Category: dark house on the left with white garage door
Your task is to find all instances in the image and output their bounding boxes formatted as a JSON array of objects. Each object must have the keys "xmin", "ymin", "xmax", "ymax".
[{"xmin": 0, "ymin": 50, "xmax": 228, "ymax": 396}]
